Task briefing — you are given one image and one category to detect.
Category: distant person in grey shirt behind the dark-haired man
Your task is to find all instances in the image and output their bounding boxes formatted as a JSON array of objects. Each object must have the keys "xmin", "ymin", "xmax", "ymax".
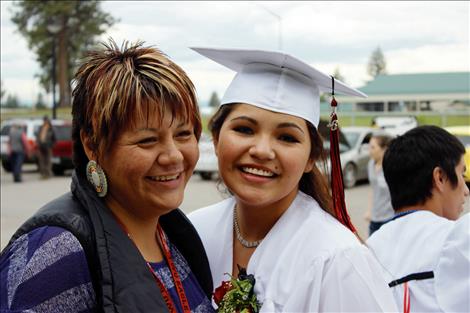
[{"xmin": 365, "ymin": 133, "xmax": 393, "ymax": 236}]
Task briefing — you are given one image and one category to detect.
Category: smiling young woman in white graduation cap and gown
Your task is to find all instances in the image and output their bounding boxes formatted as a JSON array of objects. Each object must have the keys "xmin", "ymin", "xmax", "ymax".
[{"xmin": 190, "ymin": 48, "xmax": 396, "ymax": 312}]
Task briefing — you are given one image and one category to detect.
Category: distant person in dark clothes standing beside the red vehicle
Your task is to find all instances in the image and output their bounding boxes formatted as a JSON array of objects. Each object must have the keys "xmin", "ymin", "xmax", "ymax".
[{"xmin": 36, "ymin": 115, "xmax": 56, "ymax": 179}]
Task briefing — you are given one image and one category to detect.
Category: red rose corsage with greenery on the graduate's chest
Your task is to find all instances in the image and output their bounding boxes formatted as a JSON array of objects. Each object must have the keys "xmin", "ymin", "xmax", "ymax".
[{"xmin": 214, "ymin": 267, "xmax": 261, "ymax": 313}]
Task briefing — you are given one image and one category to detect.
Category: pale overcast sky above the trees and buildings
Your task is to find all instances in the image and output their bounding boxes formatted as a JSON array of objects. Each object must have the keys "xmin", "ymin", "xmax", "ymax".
[{"xmin": 1, "ymin": 1, "xmax": 470, "ymax": 106}]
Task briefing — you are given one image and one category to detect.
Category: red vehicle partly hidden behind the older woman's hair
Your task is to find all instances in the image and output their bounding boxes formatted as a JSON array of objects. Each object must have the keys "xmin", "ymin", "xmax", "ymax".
[{"xmin": 51, "ymin": 121, "xmax": 74, "ymax": 175}]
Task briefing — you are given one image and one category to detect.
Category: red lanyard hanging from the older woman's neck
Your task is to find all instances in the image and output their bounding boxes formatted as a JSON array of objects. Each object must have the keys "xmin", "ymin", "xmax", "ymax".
[{"xmin": 114, "ymin": 215, "xmax": 191, "ymax": 313}]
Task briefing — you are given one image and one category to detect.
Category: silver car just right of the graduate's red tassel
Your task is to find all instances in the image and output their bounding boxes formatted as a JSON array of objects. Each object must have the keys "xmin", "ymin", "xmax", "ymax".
[{"xmin": 319, "ymin": 121, "xmax": 374, "ymax": 188}]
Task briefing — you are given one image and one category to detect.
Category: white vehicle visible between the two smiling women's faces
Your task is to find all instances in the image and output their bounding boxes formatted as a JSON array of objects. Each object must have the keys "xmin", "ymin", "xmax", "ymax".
[{"xmin": 194, "ymin": 133, "xmax": 219, "ymax": 180}]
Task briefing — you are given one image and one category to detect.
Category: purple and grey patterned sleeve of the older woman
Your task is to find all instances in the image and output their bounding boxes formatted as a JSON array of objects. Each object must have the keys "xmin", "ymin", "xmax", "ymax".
[{"xmin": 0, "ymin": 226, "xmax": 96, "ymax": 313}]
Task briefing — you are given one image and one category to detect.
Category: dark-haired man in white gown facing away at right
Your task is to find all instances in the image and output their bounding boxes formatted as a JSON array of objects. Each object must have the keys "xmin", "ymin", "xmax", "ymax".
[{"xmin": 367, "ymin": 126, "xmax": 470, "ymax": 313}]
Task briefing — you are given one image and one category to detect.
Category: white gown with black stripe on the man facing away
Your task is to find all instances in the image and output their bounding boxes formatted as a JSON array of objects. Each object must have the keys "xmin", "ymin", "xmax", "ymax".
[{"xmin": 367, "ymin": 211, "xmax": 470, "ymax": 312}]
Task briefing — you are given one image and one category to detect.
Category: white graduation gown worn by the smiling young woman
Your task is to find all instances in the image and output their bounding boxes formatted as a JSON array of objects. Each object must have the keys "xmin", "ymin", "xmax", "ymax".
[{"xmin": 189, "ymin": 192, "xmax": 397, "ymax": 312}]
